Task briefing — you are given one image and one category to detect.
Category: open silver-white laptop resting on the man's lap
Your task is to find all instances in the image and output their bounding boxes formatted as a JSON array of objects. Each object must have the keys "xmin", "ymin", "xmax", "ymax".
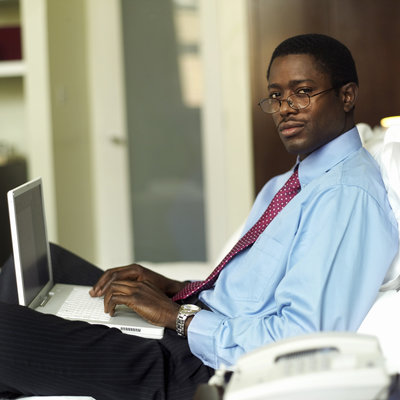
[{"xmin": 8, "ymin": 178, "xmax": 164, "ymax": 339}]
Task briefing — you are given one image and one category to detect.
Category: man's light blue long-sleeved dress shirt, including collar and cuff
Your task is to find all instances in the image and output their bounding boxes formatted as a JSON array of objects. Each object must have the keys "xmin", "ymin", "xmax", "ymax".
[{"xmin": 188, "ymin": 128, "xmax": 398, "ymax": 368}]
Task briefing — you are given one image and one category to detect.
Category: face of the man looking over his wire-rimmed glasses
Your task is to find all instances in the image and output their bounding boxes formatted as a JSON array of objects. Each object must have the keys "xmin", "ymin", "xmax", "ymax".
[{"xmin": 268, "ymin": 54, "xmax": 348, "ymax": 159}]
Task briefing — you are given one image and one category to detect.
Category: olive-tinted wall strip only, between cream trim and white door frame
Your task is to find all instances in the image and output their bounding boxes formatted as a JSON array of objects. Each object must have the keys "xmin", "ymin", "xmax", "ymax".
[{"xmin": 47, "ymin": 0, "xmax": 96, "ymax": 260}]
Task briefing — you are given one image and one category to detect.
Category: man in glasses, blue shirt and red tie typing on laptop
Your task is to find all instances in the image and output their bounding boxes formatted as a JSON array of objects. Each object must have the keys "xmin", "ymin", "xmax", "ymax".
[{"xmin": 0, "ymin": 35, "xmax": 398, "ymax": 400}]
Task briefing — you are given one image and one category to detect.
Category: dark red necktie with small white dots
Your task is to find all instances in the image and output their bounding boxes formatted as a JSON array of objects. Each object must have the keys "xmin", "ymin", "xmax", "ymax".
[{"xmin": 172, "ymin": 167, "xmax": 300, "ymax": 301}]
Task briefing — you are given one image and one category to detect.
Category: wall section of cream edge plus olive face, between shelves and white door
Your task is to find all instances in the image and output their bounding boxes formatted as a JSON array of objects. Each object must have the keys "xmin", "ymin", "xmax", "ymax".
[{"xmin": 21, "ymin": 0, "xmax": 95, "ymax": 261}]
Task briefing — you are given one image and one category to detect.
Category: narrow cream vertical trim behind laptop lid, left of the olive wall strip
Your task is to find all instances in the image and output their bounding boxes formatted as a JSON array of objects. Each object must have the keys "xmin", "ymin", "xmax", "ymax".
[{"xmin": 20, "ymin": 0, "xmax": 58, "ymax": 241}]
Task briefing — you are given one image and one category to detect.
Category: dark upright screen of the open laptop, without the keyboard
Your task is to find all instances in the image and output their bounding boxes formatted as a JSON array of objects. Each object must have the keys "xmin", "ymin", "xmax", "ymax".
[{"xmin": 8, "ymin": 182, "xmax": 50, "ymax": 305}]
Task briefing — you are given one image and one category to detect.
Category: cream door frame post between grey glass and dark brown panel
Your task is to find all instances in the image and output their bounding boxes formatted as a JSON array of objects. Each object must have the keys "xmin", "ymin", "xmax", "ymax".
[{"xmin": 200, "ymin": 0, "xmax": 254, "ymax": 260}]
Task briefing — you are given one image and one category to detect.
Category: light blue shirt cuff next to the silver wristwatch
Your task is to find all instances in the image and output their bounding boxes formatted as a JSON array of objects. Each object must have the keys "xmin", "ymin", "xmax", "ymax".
[{"xmin": 187, "ymin": 310, "xmax": 227, "ymax": 369}]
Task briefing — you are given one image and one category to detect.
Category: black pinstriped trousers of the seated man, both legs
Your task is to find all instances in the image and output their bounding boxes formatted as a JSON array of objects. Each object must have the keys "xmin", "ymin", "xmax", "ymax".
[{"xmin": 0, "ymin": 245, "xmax": 214, "ymax": 400}]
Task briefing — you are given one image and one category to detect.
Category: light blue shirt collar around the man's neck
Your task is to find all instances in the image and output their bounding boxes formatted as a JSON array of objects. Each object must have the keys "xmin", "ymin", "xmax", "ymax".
[{"xmin": 297, "ymin": 127, "xmax": 362, "ymax": 187}]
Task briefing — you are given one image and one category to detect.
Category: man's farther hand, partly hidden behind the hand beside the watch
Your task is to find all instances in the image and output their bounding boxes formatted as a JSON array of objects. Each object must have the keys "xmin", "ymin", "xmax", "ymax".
[{"xmin": 90, "ymin": 264, "xmax": 185, "ymax": 297}]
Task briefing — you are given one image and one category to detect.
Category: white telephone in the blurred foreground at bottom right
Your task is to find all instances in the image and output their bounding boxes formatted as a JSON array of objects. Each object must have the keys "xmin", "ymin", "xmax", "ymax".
[{"xmin": 223, "ymin": 332, "xmax": 391, "ymax": 400}]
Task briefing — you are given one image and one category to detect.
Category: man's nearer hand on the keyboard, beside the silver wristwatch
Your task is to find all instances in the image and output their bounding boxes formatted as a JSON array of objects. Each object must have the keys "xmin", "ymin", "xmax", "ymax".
[{"xmin": 104, "ymin": 281, "xmax": 179, "ymax": 330}]
